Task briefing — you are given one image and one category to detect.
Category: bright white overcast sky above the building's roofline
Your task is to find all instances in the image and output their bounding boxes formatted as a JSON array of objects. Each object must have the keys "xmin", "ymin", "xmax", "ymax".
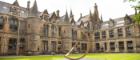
[{"xmin": 0, "ymin": 0, "xmax": 134, "ymax": 21}]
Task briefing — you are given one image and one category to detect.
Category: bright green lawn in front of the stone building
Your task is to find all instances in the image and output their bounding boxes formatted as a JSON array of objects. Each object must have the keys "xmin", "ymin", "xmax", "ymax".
[{"xmin": 0, "ymin": 53, "xmax": 140, "ymax": 60}]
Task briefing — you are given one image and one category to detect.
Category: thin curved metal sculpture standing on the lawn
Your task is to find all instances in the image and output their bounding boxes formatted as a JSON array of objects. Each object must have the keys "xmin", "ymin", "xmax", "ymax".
[{"xmin": 64, "ymin": 32, "xmax": 89, "ymax": 60}]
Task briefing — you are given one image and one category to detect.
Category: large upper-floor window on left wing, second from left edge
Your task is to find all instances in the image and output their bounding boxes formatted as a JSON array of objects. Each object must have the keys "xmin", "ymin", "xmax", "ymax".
[{"xmin": 9, "ymin": 17, "xmax": 18, "ymax": 32}]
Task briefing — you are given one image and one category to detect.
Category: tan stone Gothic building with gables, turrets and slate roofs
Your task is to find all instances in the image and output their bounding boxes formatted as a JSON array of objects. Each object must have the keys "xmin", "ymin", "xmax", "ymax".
[{"xmin": 0, "ymin": 0, "xmax": 140, "ymax": 55}]
